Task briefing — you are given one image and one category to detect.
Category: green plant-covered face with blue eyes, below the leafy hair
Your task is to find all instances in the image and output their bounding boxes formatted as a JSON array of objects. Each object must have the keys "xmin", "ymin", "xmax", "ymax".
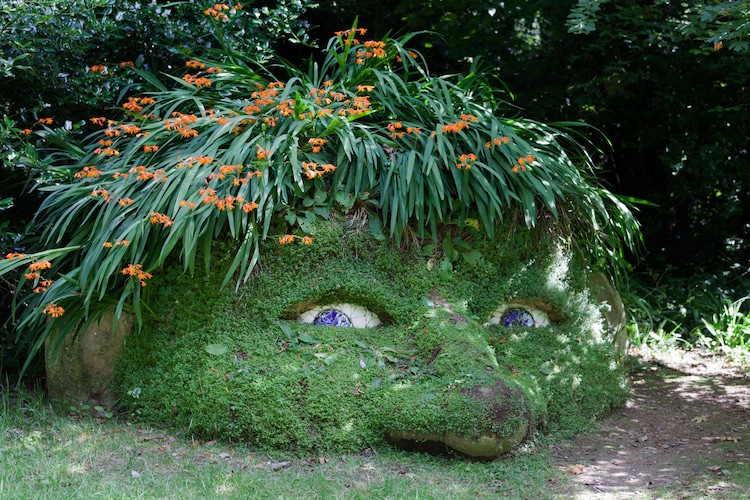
[{"xmin": 114, "ymin": 221, "xmax": 625, "ymax": 457}]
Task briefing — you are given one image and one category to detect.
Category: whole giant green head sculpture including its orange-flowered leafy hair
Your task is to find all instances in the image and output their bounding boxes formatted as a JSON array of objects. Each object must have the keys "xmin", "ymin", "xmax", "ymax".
[{"xmin": 0, "ymin": 29, "xmax": 638, "ymax": 456}]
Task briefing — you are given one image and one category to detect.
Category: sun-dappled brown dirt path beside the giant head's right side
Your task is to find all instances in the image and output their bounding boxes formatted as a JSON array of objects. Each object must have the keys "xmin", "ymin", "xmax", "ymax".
[{"xmin": 554, "ymin": 355, "xmax": 750, "ymax": 499}]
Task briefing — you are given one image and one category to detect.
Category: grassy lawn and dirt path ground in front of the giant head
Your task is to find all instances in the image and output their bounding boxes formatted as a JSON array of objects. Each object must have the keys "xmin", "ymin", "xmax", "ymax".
[{"xmin": 0, "ymin": 352, "xmax": 750, "ymax": 500}]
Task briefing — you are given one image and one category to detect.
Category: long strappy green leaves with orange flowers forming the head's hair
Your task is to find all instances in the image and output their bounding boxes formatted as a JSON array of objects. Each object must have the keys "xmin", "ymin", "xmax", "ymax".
[{"xmin": 0, "ymin": 27, "xmax": 638, "ymax": 376}]
